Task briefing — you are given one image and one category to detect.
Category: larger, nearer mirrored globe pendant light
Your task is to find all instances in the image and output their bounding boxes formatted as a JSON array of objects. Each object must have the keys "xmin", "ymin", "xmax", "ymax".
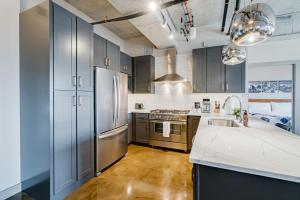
[{"xmin": 230, "ymin": 3, "xmax": 275, "ymax": 46}]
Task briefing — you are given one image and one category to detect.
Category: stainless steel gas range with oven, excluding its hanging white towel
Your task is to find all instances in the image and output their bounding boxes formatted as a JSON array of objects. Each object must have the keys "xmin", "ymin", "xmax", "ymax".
[{"xmin": 150, "ymin": 110, "xmax": 189, "ymax": 151}]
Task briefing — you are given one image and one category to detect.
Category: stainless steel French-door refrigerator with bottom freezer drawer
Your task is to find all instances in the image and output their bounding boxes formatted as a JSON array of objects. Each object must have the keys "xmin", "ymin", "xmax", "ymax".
[{"xmin": 95, "ymin": 67, "xmax": 128, "ymax": 175}]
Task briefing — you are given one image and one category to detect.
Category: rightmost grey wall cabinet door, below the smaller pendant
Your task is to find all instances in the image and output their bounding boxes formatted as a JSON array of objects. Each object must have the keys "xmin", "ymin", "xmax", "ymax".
[{"xmin": 225, "ymin": 63, "xmax": 245, "ymax": 93}]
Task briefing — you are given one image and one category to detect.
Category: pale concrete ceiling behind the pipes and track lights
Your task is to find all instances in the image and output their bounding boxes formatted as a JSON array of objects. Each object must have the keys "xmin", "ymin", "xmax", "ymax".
[{"xmin": 66, "ymin": 0, "xmax": 300, "ymax": 52}]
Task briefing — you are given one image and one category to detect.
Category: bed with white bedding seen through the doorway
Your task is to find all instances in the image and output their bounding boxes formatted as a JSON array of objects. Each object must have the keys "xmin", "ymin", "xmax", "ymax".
[{"xmin": 248, "ymin": 99, "xmax": 292, "ymax": 131}]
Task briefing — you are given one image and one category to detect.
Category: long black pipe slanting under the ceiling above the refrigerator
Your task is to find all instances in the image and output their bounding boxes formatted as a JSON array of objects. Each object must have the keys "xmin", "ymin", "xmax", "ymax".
[{"xmin": 91, "ymin": 0, "xmax": 188, "ymax": 25}]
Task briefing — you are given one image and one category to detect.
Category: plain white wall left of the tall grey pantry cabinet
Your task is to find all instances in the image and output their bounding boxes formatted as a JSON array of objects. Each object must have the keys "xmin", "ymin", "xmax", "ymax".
[{"xmin": 0, "ymin": 0, "xmax": 20, "ymax": 196}]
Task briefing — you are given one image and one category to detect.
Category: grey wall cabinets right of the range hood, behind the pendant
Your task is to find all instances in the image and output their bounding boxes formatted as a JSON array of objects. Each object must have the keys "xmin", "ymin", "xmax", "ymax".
[{"xmin": 193, "ymin": 46, "xmax": 245, "ymax": 93}]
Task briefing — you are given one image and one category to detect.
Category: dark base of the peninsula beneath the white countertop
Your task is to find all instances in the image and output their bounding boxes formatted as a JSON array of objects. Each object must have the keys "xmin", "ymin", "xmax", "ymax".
[{"xmin": 193, "ymin": 164, "xmax": 300, "ymax": 200}]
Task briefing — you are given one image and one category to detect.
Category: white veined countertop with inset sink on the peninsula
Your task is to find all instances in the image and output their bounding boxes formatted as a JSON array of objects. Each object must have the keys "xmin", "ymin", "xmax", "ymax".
[{"xmin": 190, "ymin": 111, "xmax": 300, "ymax": 183}]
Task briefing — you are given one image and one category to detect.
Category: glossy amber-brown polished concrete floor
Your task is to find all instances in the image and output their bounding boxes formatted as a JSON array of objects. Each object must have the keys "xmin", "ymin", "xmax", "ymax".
[{"xmin": 67, "ymin": 145, "xmax": 192, "ymax": 200}]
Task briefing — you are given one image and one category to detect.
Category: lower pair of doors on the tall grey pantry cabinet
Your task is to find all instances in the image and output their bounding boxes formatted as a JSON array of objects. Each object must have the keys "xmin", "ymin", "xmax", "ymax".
[{"xmin": 53, "ymin": 91, "xmax": 94, "ymax": 198}]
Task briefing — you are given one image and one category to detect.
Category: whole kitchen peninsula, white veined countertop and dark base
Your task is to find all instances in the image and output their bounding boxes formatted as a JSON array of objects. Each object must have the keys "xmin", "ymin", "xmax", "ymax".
[{"xmin": 190, "ymin": 113, "xmax": 300, "ymax": 200}]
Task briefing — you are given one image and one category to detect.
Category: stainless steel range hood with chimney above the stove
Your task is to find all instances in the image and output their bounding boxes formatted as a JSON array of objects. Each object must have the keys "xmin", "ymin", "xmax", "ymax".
[{"xmin": 154, "ymin": 48, "xmax": 185, "ymax": 83}]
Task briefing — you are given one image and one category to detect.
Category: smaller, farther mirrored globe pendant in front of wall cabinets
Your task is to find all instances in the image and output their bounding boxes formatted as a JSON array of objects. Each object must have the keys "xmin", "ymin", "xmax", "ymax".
[{"xmin": 222, "ymin": 44, "xmax": 246, "ymax": 65}]
